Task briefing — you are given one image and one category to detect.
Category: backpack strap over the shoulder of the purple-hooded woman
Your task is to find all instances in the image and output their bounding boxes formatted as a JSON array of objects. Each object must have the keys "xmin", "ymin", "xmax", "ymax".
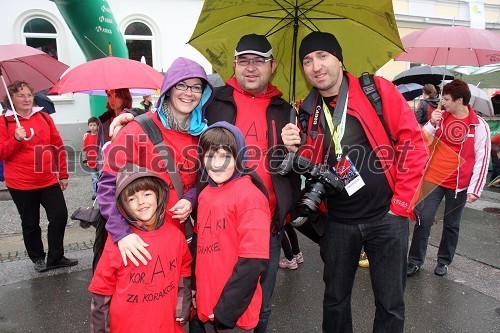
[{"xmin": 134, "ymin": 114, "xmax": 193, "ymax": 243}]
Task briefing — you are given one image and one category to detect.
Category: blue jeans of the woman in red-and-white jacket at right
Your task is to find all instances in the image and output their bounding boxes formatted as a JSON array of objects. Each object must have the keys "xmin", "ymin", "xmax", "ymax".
[{"xmin": 408, "ymin": 183, "xmax": 467, "ymax": 266}]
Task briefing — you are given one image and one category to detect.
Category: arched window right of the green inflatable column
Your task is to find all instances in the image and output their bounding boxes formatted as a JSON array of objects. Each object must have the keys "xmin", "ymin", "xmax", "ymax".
[{"xmin": 124, "ymin": 22, "xmax": 153, "ymax": 67}]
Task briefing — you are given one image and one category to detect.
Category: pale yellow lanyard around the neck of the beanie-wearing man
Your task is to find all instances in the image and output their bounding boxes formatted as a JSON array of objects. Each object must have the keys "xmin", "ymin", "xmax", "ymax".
[{"xmin": 323, "ymin": 76, "xmax": 349, "ymax": 161}]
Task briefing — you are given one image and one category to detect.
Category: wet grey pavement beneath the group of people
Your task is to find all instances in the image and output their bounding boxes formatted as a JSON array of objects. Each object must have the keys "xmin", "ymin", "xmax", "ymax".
[{"xmin": 0, "ymin": 165, "xmax": 500, "ymax": 333}]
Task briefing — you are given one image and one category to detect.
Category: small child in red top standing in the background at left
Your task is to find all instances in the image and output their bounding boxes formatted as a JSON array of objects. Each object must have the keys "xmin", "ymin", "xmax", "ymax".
[{"xmin": 82, "ymin": 117, "xmax": 99, "ymax": 200}]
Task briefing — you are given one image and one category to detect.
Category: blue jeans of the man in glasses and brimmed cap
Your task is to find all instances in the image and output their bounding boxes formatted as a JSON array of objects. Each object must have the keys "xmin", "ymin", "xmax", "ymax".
[{"xmin": 254, "ymin": 229, "xmax": 283, "ymax": 333}]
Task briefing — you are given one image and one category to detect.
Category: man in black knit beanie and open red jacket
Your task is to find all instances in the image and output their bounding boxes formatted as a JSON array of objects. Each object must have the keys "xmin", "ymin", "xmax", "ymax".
[{"xmin": 281, "ymin": 32, "xmax": 427, "ymax": 333}]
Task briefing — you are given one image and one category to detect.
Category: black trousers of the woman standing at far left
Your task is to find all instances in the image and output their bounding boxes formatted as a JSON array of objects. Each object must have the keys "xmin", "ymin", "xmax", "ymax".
[{"xmin": 9, "ymin": 184, "xmax": 68, "ymax": 265}]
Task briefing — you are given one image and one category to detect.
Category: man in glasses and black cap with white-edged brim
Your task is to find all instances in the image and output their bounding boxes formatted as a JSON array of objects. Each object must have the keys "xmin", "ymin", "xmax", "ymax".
[{"xmin": 205, "ymin": 34, "xmax": 300, "ymax": 333}]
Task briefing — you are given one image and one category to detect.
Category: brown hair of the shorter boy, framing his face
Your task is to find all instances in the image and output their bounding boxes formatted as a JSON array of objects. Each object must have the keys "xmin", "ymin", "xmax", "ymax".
[{"xmin": 118, "ymin": 176, "xmax": 167, "ymax": 229}]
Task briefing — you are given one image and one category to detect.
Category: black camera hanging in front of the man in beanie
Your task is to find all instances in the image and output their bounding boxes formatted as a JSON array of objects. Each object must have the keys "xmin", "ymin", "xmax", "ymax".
[{"xmin": 278, "ymin": 152, "xmax": 345, "ymax": 216}]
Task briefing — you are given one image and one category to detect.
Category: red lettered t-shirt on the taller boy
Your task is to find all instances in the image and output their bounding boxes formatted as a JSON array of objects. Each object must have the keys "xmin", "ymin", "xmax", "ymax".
[{"xmin": 196, "ymin": 176, "xmax": 271, "ymax": 329}]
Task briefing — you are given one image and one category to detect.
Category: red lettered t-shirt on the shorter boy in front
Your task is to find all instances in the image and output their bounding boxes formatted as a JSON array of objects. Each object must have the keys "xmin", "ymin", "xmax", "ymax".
[{"xmin": 89, "ymin": 224, "xmax": 191, "ymax": 333}]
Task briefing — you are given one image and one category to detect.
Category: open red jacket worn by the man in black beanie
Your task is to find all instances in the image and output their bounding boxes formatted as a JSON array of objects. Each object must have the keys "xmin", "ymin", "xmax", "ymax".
[{"xmin": 299, "ymin": 73, "xmax": 428, "ymax": 220}]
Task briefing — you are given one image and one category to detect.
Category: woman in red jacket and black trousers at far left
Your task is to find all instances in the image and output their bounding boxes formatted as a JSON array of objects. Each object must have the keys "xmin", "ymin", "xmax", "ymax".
[{"xmin": 0, "ymin": 81, "xmax": 78, "ymax": 272}]
